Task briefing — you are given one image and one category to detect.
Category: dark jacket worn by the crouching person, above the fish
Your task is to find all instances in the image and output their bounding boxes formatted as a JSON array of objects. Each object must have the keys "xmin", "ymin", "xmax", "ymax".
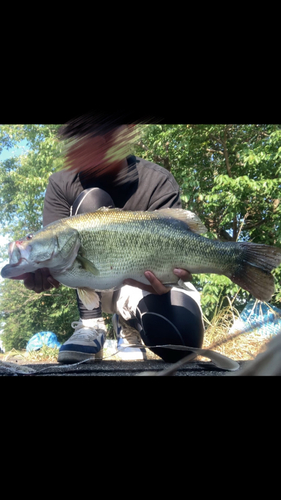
[{"xmin": 43, "ymin": 156, "xmax": 181, "ymax": 226}]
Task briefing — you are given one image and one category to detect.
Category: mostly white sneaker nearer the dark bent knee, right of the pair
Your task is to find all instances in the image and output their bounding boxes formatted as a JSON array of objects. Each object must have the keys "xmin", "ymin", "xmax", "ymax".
[{"xmin": 112, "ymin": 314, "xmax": 146, "ymax": 361}]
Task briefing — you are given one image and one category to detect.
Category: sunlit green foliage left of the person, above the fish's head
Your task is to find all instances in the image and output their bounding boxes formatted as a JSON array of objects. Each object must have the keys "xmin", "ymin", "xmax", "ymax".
[{"xmin": 0, "ymin": 125, "xmax": 63, "ymax": 239}]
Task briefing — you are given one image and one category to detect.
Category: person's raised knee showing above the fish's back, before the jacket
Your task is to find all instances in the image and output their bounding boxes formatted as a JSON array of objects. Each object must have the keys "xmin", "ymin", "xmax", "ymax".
[{"xmin": 71, "ymin": 187, "xmax": 115, "ymax": 215}]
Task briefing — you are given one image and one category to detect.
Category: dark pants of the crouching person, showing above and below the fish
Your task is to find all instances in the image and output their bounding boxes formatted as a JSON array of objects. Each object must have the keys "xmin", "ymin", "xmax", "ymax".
[{"xmin": 72, "ymin": 188, "xmax": 204, "ymax": 362}]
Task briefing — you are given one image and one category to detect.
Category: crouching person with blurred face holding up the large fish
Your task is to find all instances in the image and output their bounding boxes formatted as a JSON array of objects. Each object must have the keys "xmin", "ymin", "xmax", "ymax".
[{"xmin": 20, "ymin": 119, "xmax": 204, "ymax": 363}]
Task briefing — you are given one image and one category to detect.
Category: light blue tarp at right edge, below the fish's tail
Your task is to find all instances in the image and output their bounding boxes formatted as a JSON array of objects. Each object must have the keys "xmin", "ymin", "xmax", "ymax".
[{"xmin": 231, "ymin": 299, "xmax": 281, "ymax": 337}]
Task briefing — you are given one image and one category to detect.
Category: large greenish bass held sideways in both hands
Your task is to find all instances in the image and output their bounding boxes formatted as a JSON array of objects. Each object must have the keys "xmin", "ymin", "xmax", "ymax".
[{"xmin": 1, "ymin": 207, "xmax": 281, "ymax": 310}]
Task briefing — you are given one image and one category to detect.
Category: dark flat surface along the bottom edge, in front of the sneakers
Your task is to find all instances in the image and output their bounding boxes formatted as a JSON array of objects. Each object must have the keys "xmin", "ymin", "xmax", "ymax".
[{"xmin": 0, "ymin": 360, "xmax": 243, "ymax": 378}]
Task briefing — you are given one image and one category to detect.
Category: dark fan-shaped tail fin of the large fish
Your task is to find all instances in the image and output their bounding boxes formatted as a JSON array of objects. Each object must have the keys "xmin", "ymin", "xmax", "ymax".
[{"xmin": 229, "ymin": 243, "xmax": 281, "ymax": 301}]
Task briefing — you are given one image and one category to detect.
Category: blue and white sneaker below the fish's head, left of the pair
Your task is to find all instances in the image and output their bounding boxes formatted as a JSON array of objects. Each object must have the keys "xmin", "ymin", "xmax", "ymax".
[{"xmin": 58, "ymin": 318, "xmax": 106, "ymax": 363}]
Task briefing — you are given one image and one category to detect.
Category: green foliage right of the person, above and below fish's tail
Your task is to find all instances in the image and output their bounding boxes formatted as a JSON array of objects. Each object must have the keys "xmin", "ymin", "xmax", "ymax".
[{"xmin": 135, "ymin": 124, "xmax": 281, "ymax": 320}]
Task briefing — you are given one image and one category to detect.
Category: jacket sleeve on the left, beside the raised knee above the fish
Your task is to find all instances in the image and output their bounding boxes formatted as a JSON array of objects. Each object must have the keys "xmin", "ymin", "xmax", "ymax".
[{"xmin": 43, "ymin": 176, "xmax": 70, "ymax": 226}]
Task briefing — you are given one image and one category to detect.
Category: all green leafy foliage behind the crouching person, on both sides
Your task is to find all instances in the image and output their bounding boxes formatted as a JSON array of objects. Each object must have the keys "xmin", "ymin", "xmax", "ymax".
[{"xmin": 0, "ymin": 124, "xmax": 281, "ymax": 349}]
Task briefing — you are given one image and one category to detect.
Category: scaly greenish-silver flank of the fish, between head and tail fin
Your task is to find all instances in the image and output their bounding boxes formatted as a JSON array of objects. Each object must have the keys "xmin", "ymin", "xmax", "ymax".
[{"xmin": 60, "ymin": 211, "xmax": 236, "ymax": 282}]
